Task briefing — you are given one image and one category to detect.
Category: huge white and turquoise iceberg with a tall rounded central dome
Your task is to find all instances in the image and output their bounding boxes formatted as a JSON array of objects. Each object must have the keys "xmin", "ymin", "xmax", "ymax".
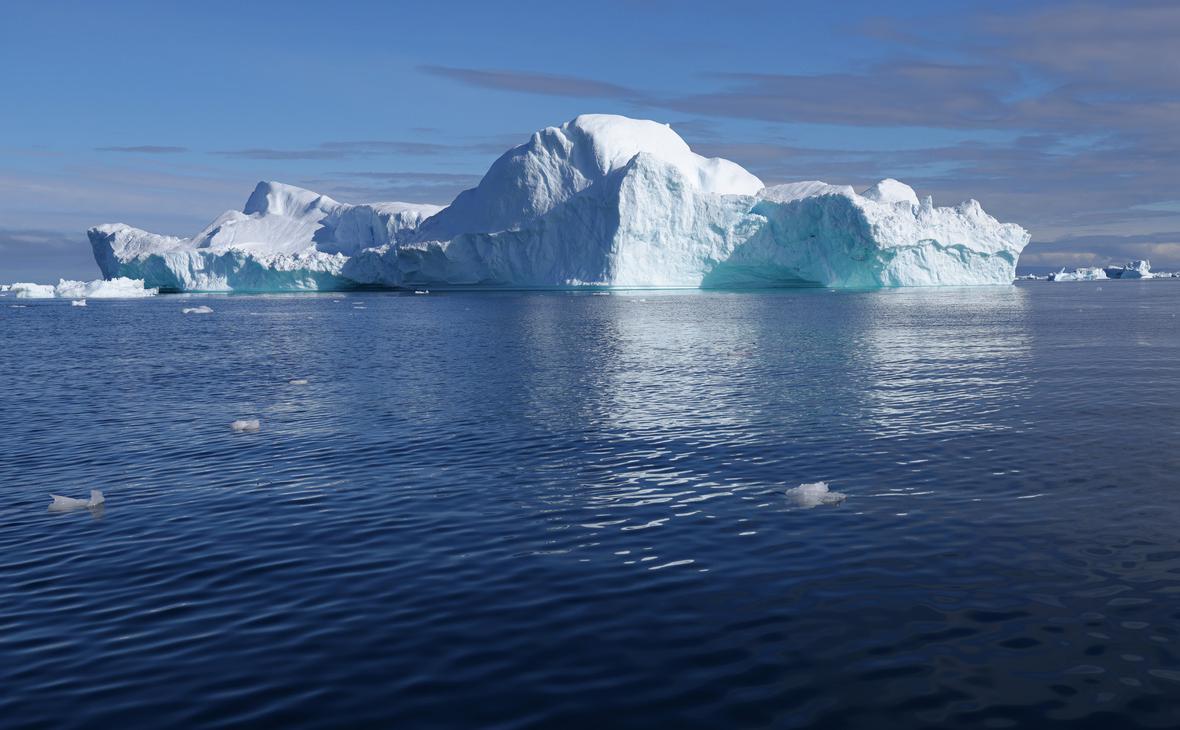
[{"xmin": 89, "ymin": 114, "xmax": 1029, "ymax": 291}]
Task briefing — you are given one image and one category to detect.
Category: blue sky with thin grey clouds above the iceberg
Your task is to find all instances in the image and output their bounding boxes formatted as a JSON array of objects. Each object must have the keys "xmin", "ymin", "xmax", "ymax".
[{"xmin": 0, "ymin": 0, "xmax": 1180, "ymax": 282}]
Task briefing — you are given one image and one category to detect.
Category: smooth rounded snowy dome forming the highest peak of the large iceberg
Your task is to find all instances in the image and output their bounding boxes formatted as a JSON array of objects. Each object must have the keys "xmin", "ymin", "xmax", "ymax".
[{"xmin": 419, "ymin": 114, "xmax": 762, "ymax": 241}]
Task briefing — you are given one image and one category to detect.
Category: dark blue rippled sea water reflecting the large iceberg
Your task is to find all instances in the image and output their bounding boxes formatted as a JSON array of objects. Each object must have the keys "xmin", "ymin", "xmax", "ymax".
[{"xmin": 0, "ymin": 281, "xmax": 1180, "ymax": 730}]
